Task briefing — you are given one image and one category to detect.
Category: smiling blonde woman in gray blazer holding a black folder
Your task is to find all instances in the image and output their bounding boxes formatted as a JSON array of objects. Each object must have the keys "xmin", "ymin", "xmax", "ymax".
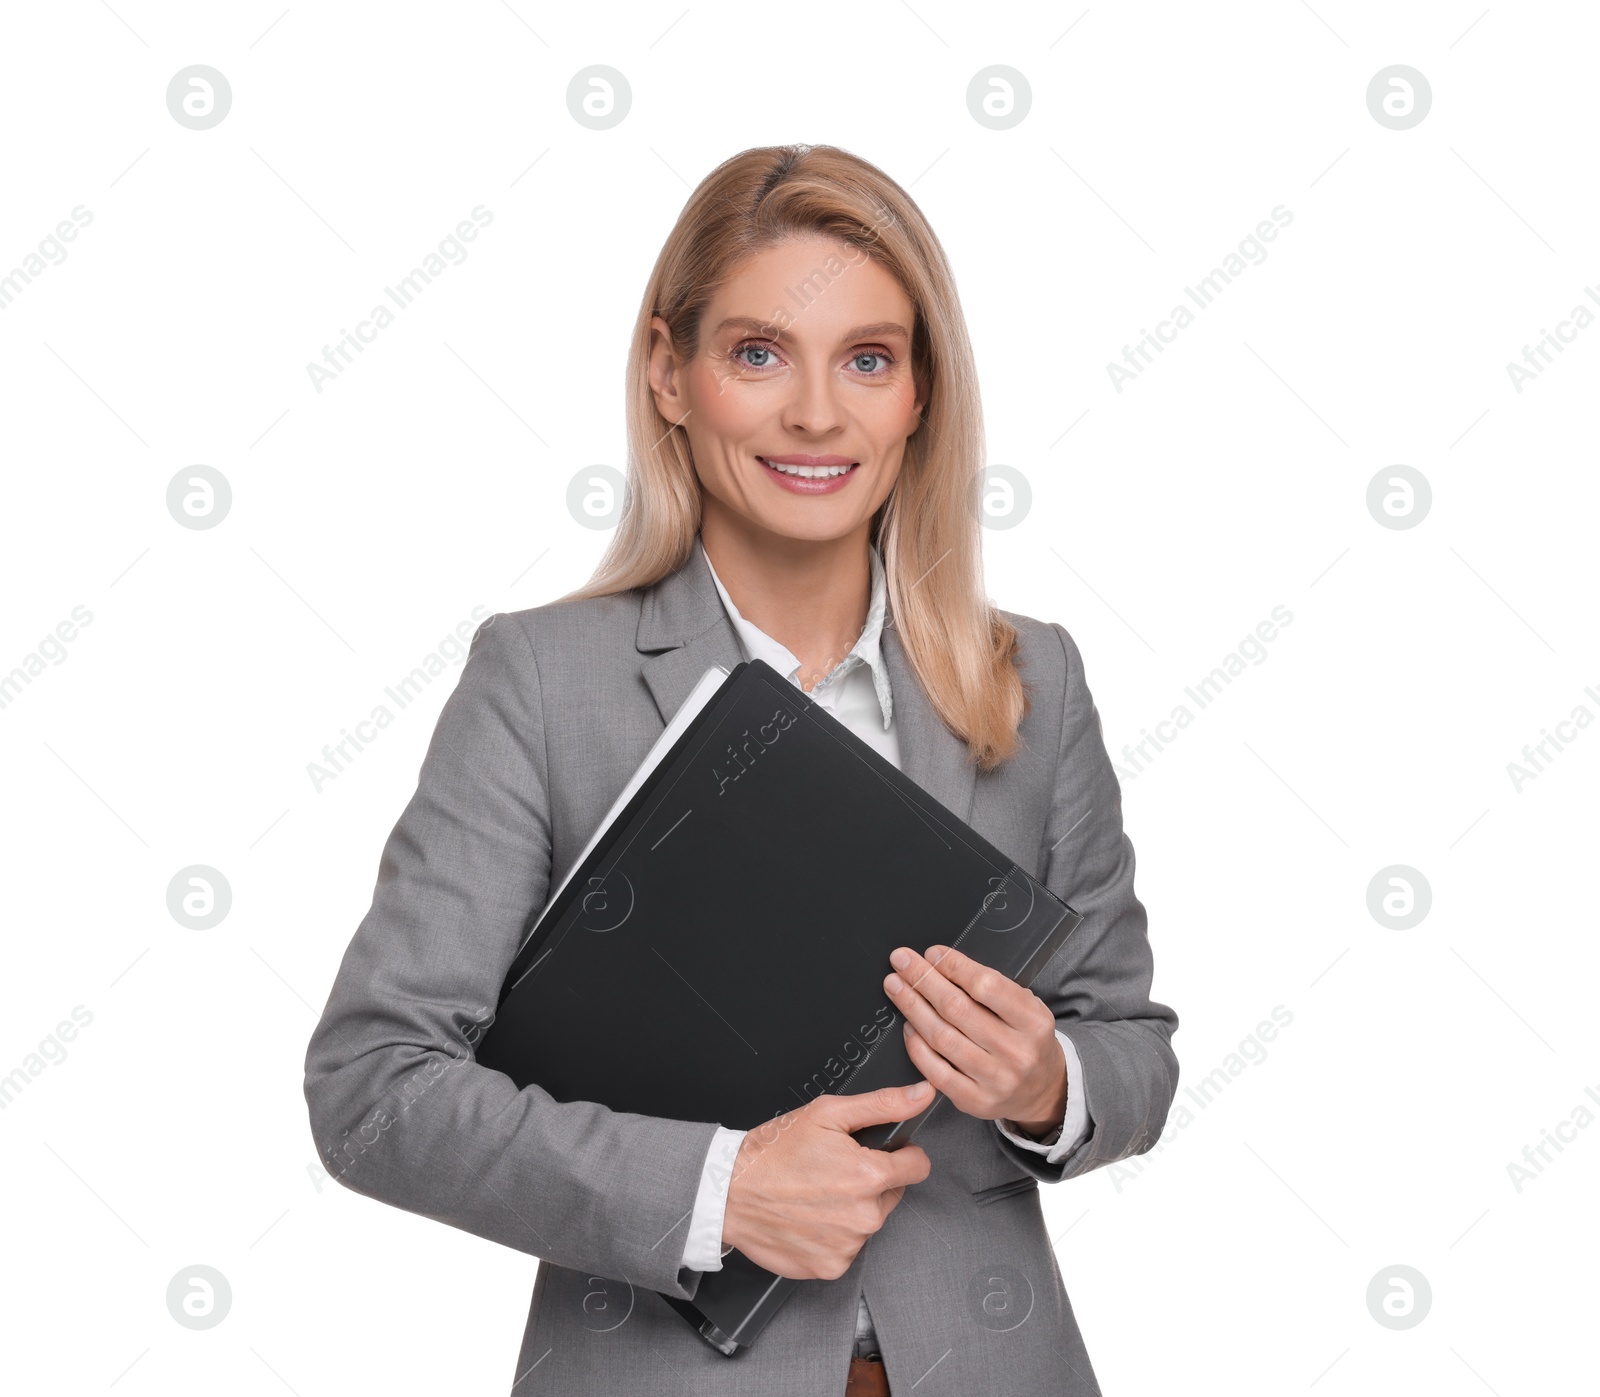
[{"xmin": 306, "ymin": 146, "xmax": 1178, "ymax": 1397}]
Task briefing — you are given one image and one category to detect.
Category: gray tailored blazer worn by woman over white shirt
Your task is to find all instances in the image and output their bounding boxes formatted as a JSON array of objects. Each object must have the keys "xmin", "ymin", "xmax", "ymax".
[{"xmin": 306, "ymin": 547, "xmax": 1178, "ymax": 1397}]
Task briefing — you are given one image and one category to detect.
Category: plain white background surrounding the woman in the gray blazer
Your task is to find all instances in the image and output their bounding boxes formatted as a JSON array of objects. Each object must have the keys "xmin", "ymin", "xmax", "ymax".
[{"xmin": 0, "ymin": 0, "xmax": 1600, "ymax": 1397}]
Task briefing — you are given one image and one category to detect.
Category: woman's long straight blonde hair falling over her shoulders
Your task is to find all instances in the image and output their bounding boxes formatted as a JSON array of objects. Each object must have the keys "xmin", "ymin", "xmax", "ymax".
[{"xmin": 560, "ymin": 146, "xmax": 1029, "ymax": 771}]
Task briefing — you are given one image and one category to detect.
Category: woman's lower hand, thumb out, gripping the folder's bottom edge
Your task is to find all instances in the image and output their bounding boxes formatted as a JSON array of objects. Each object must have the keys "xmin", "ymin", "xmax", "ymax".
[{"xmin": 722, "ymin": 1082, "xmax": 933, "ymax": 1280}]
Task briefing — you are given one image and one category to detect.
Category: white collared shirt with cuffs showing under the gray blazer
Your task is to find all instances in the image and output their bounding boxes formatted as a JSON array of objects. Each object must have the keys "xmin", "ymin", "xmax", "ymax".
[{"xmin": 680, "ymin": 547, "xmax": 1090, "ymax": 1355}]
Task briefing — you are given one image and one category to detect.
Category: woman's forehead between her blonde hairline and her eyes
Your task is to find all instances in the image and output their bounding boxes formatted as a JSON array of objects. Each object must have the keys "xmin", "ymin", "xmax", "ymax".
[{"xmin": 704, "ymin": 235, "xmax": 914, "ymax": 344}]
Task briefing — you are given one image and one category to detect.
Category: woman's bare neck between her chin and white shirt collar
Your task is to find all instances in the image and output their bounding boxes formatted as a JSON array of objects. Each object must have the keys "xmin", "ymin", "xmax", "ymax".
[{"xmin": 701, "ymin": 496, "xmax": 872, "ymax": 690}]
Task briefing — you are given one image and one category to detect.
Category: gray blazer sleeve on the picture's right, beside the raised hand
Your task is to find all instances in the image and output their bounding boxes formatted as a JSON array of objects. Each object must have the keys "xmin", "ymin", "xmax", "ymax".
[{"xmin": 1000, "ymin": 624, "xmax": 1178, "ymax": 1183}]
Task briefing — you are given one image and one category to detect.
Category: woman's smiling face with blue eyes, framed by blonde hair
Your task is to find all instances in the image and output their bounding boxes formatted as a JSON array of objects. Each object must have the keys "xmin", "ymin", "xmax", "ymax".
[{"xmin": 650, "ymin": 235, "xmax": 923, "ymax": 541}]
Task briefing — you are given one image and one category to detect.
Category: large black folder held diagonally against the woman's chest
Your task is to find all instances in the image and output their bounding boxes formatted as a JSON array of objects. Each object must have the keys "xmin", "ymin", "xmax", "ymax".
[{"xmin": 477, "ymin": 659, "xmax": 1082, "ymax": 1355}]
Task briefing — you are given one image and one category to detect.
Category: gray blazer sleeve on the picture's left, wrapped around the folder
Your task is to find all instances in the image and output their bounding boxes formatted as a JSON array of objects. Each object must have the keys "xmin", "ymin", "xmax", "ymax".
[{"xmin": 304, "ymin": 613, "xmax": 718, "ymax": 1299}]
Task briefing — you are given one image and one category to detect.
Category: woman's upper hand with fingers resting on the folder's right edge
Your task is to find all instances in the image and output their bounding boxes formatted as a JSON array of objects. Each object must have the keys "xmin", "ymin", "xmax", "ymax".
[{"xmin": 883, "ymin": 946, "xmax": 1067, "ymax": 1135}]
